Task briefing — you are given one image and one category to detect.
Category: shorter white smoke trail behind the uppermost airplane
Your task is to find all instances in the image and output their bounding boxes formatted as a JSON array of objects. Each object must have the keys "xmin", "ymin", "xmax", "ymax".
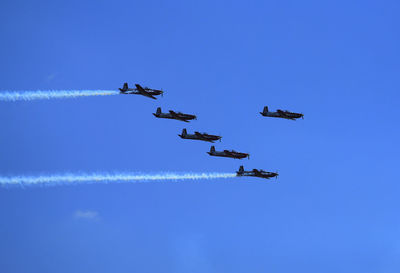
[{"xmin": 0, "ymin": 90, "xmax": 119, "ymax": 101}]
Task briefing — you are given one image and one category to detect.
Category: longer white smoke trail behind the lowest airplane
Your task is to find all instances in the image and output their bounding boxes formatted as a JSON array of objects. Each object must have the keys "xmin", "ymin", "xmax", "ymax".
[{"xmin": 0, "ymin": 173, "xmax": 236, "ymax": 186}]
